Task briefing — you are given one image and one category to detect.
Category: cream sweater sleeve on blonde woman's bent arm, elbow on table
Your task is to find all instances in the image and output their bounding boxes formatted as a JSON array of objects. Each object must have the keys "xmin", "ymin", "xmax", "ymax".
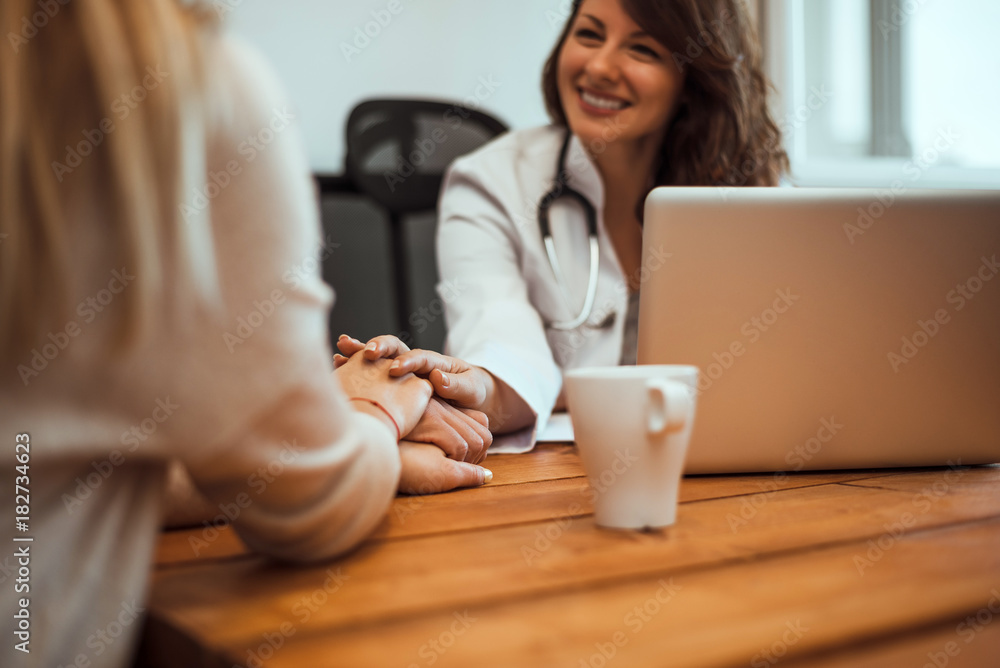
[{"xmin": 181, "ymin": 38, "xmax": 400, "ymax": 561}]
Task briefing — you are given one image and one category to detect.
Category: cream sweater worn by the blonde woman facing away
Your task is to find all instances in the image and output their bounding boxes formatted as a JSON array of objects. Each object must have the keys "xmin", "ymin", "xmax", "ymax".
[{"xmin": 0, "ymin": 37, "xmax": 400, "ymax": 668}]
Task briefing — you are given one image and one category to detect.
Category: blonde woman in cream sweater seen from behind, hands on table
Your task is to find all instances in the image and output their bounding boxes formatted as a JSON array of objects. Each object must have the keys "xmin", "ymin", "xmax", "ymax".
[{"xmin": 0, "ymin": 0, "xmax": 491, "ymax": 666}]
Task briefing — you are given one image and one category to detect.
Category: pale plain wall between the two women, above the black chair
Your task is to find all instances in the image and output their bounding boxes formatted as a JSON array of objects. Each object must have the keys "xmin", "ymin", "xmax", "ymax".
[{"xmin": 225, "ymin": 0, "xmax": 571, "ymax": 173}]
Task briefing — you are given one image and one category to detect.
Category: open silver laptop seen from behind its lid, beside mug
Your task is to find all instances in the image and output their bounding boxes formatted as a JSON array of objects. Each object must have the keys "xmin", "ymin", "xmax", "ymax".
[{"xmin": 638, "ymin": 188, "xmax": 1000, "ymax": 474}]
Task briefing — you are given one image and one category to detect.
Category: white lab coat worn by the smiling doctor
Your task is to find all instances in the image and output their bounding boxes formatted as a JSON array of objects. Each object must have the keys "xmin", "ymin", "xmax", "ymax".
[{"xmin": 437, "ymin": 126, "xmax": 628, "ymax": 452}]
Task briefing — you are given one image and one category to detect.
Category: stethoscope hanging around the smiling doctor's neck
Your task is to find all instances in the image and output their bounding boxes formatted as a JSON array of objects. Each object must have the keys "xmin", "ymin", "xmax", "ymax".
[{"xmin": 538, "ymin": 130, "xmax": 600, "ymax": 331}]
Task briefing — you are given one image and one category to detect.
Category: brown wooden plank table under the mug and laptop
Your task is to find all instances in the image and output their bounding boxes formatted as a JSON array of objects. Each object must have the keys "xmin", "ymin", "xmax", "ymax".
[{"xmin": 139, "ymin": 445, "xmax": 1000, "ymax": 668}]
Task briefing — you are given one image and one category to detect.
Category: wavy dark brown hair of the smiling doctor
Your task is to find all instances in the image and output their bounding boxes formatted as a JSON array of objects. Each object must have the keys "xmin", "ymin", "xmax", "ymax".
[{"xmin": 542, "ymin": 0, "xmax": 789, "ymax": 186}]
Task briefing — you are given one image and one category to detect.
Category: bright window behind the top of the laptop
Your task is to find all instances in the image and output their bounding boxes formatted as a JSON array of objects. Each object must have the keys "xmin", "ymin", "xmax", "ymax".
[{"xmin": 758, "ymin": 0, "xmax": 1000, "ymax": 188}]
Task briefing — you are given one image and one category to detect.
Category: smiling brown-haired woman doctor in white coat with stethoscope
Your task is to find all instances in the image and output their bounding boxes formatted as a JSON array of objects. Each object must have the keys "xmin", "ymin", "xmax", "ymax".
[{"xmin": 338, "ymin": 0, "xmax": 788, "ymax": 452}]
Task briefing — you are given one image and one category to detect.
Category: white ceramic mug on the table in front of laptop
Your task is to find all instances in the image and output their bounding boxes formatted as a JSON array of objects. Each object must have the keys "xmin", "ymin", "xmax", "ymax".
[{"xmin": 565, "ymin": 365, "xmax": 698, "ymax": 529}]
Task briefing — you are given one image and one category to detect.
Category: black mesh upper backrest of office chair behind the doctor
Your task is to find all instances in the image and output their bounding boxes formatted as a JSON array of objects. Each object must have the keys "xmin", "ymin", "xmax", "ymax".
[{"xmin": 346, "ymin": 100, "xmax": 507, "ymax": 215}]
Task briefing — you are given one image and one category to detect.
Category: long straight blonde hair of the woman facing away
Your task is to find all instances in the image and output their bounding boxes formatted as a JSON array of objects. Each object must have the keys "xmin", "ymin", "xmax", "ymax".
[{"xmin": 0, "ymin": 0, "xmax": 214, "ymax": 361}]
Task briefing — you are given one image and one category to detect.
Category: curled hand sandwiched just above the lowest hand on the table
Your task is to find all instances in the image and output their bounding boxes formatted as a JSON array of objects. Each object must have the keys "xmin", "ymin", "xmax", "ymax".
[{"xmin": 406, "ymin": 397, "xmax": 493, "ymax": 464}]
